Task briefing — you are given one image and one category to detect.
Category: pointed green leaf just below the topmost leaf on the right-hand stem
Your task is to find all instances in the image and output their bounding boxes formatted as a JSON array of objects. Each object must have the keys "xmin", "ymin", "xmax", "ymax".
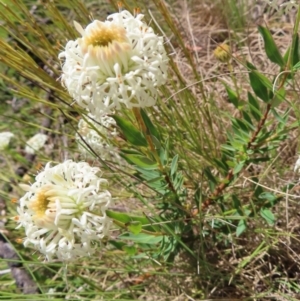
[{"xmin": 247, "ymin": 62, "xmax": 272, "ymax": 102}]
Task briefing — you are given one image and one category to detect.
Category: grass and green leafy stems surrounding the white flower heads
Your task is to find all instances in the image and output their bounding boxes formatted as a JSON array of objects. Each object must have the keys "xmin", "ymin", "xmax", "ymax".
[{"xmin": 0, "ymin": 0, "xmax": 300, "ymax": 300}]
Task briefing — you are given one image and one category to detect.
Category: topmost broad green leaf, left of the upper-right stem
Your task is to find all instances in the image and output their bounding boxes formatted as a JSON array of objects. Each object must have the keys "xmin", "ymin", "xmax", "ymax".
[{"xmin": 258, "ymin": 26, "xmax": 285, "ymax": 67}]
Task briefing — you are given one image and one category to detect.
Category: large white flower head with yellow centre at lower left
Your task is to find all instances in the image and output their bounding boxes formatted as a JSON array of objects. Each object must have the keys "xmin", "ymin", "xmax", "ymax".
[{"xmin": 15, "ymin": 160, "xmax": 112, "ymax": 261}]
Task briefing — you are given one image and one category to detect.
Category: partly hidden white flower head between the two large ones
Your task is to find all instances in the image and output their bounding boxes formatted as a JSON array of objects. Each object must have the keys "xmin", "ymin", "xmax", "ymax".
[{"xmin": 76, "ymin": 116, "xmax": 119, "ymax": 160}]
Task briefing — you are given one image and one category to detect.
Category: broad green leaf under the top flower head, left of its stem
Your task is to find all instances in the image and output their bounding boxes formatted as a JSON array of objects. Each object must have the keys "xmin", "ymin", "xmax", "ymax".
[{"xmin": 112, "ymin": 115, "xmax": 148, "ymax": 146}]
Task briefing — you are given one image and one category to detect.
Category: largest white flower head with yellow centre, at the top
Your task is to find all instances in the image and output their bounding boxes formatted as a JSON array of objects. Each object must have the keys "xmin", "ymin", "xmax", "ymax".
[{"xmin": 59, "ymin": 10, "xmax": 168, "ymax": 118}]
